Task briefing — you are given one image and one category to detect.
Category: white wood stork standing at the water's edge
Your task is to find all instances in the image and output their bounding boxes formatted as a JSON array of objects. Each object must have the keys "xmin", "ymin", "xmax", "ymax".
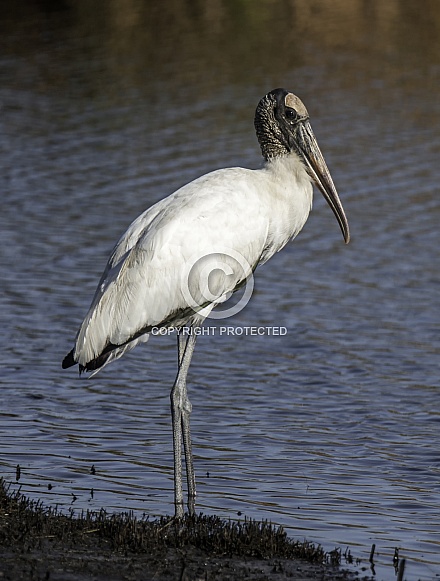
[{"xmin": 62, "ymin": 89, "xmax": 350, "ymax": 517}]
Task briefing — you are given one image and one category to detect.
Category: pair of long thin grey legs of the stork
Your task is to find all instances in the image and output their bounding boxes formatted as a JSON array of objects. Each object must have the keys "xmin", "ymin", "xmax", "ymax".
[{"xmin": 171, "ymin": 326, "xmax": 197, "ymax": 518}]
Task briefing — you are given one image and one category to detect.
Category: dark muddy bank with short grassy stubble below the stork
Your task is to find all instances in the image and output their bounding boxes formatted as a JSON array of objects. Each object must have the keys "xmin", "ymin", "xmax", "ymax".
[{"xmin": 0, "ymin": 481, "xmax": 372, "ymax": 581}]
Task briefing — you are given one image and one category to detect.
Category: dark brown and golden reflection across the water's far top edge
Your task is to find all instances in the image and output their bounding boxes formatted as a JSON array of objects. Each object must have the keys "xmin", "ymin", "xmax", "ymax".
[{"xmin": 0, "ymin": 0, "xmax": 440, "ymax": 100}]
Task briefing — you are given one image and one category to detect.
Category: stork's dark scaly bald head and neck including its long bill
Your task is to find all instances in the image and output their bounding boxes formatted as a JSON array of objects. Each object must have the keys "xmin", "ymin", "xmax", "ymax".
[{"xmin": 255, "ymin": 89, "xmax": 350, "ymax": 244}]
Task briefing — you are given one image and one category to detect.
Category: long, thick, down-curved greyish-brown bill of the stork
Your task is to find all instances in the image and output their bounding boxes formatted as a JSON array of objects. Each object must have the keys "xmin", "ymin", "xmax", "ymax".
[{"xmin": 295, "ymin": 120, "xmax": 350, "ymax": 244}]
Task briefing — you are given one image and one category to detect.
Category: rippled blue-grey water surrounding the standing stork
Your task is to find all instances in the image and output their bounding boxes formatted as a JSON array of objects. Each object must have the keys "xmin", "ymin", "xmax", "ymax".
[{"xmin": 0, "ymin": 0, "xmax": 440, "ymax": 580}]
